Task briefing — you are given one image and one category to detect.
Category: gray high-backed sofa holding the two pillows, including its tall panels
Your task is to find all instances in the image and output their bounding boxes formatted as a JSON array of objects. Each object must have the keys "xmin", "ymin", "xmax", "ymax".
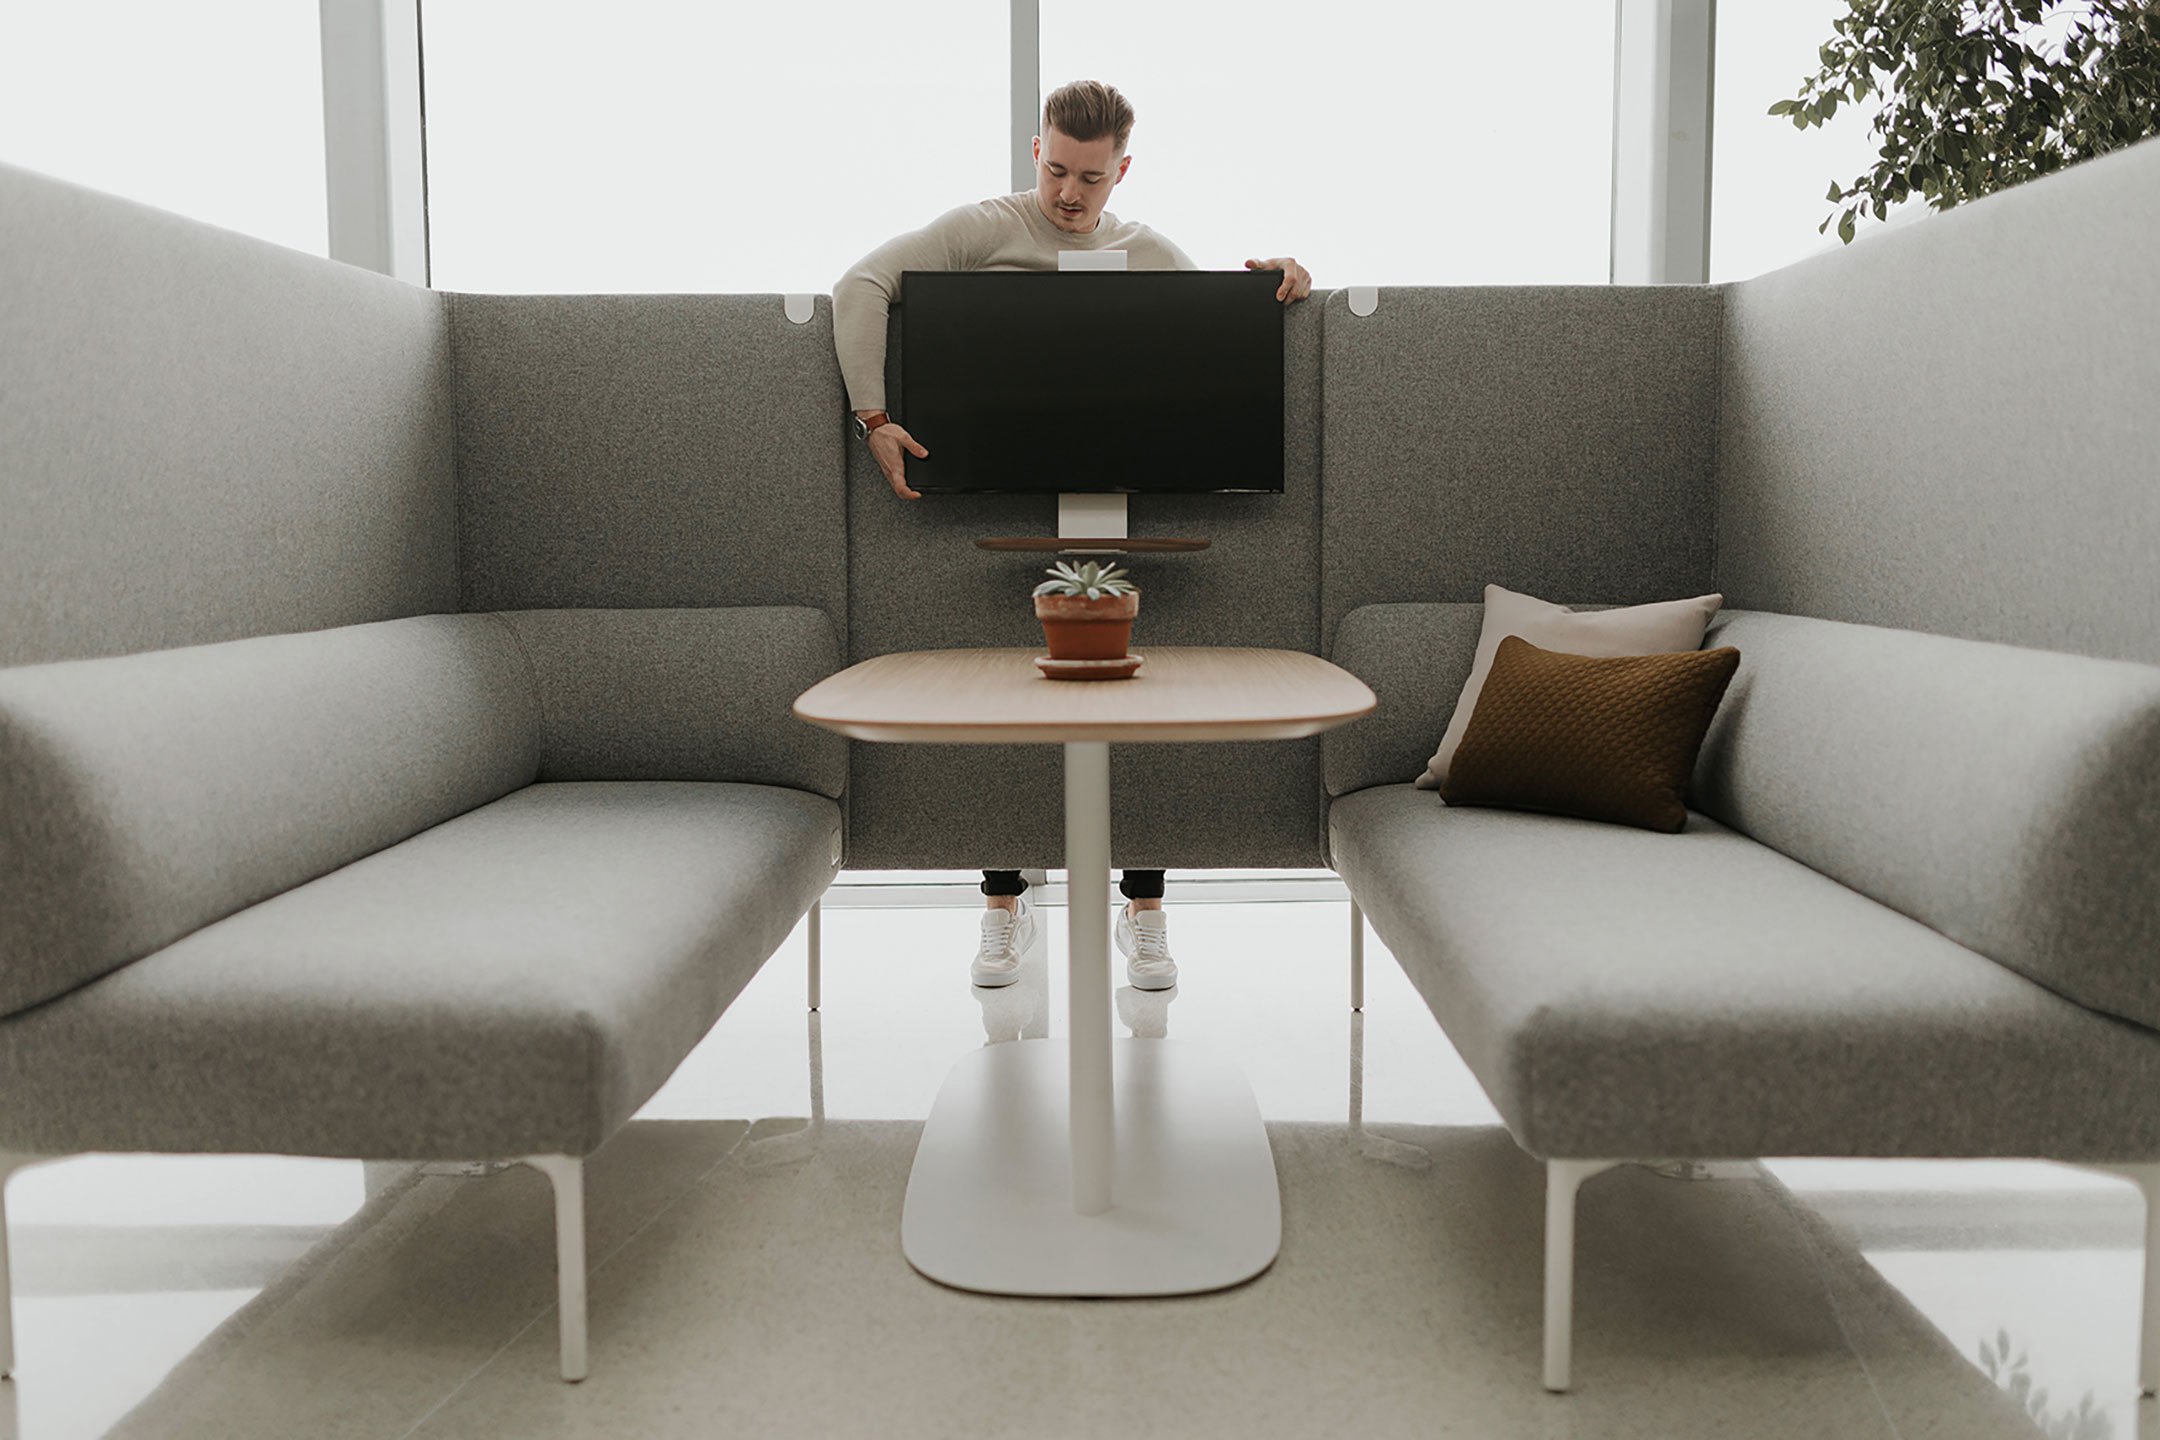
[{"xmin": 1322, "ymin": 140, "xmax": 2160, "ymax": 1395}]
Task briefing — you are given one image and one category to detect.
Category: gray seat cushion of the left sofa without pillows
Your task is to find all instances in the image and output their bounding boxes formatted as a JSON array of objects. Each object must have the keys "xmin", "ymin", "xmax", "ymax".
[{"xmin": 0, "ymin": 782, "xmax": 840, "ymax": 1159}]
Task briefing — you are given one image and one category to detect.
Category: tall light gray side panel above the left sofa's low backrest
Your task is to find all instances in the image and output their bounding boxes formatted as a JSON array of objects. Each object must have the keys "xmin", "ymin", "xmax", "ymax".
[{"xmin": 0, "ymin": 164, "xmax": 458, "ymax": 665}]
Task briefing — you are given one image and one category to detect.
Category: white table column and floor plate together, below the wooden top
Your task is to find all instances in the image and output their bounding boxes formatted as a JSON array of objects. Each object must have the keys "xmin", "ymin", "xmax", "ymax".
[{"xmin": 901, "ymin": 741, "xmax": 1283, "ymax": 1295}]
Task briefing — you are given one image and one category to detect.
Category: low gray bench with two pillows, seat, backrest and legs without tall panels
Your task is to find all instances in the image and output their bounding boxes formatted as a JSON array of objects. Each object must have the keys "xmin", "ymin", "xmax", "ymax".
[{"xmin": 1328, "ymin": 604, "xmax": 2160, "ymax": 1390}]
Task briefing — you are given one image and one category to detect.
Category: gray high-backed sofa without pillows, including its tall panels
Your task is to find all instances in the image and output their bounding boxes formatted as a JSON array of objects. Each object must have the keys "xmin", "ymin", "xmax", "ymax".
[{"xmin": 0, "ymin": 166, "xmax": 847, "ymax": 1380}]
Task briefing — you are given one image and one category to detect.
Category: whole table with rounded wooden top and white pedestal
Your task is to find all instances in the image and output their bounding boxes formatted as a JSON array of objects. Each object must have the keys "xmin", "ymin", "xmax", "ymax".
[{"xmin": 795, "ymin": 660, "xmax": 1378, "ymax": 1295}]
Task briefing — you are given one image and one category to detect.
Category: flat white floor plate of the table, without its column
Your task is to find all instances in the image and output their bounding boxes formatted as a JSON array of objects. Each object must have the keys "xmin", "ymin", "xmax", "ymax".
[{"xmin": 901, "ymin": 1041, "xmax": 1283, "ymax": 1295}]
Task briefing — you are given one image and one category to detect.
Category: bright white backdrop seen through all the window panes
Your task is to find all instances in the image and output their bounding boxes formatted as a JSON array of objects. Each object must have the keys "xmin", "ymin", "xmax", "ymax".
[{"xmin": 0, "ymin": 0, "xmax": 1978, "ymax": 291}]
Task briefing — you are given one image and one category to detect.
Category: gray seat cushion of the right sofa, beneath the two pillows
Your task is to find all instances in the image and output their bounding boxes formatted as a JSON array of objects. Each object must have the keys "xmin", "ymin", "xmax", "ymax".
[{"xmin": 1328, "ymin": 784, "xmax": 2160, "ymax": 1159}]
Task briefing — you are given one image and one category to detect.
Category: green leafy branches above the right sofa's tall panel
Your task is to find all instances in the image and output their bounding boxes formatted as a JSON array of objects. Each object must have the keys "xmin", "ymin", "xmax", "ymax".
[{"xmin": 1769, "ymin": 0, "xmax": 2160, "ymax": 244}]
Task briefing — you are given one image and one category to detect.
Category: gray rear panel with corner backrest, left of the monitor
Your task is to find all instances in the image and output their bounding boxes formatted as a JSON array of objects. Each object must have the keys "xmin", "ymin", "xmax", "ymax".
[{"xmin": 447, "ymin": 294, "xmax": 849, "ymax": 837}]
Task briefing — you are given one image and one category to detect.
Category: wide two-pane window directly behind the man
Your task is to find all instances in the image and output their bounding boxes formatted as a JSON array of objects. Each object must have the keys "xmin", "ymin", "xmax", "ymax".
[{"xmin": 423, "ymin": 0, "xmax": 1614, "ymax": 291}]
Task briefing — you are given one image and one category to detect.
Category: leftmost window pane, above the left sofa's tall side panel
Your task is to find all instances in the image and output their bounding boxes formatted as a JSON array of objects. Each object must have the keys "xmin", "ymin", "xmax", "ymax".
[{"xmin": 0, "ymin": 0, "xmax": 328, "ymax": 255}]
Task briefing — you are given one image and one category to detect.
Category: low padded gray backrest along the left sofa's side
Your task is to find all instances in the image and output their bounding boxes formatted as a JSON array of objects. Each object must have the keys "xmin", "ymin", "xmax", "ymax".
[{"xmin": 0, "ymin": 615, "xmax": 540, "ymax": 1015}]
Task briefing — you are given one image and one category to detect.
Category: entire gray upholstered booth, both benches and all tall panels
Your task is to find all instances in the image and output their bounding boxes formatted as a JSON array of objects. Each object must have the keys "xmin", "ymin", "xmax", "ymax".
[{"xmin": 12, "ymin": 129, "xmax": 2160, "ymax": 1388}]
